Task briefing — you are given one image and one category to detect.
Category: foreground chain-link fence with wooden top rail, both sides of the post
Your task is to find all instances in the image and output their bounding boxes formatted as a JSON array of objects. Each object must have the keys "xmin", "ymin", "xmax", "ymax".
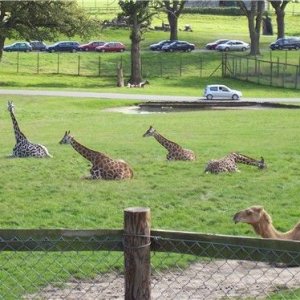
[{"xmin": 0, "ymin": 230, "xmax": 300, "ymax": 300}]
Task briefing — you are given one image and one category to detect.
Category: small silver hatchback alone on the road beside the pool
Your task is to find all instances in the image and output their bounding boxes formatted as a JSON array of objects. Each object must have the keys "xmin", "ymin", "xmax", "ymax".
[{"xmin": 204, "ymin": 84, "xmax": 242, "ymax": 100}]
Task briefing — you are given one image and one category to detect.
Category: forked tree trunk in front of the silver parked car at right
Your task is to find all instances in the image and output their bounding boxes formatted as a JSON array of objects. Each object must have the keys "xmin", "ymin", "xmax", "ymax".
[{"xmin": 238, "ymin": 0, "xmax": 265, "ymax": 55}]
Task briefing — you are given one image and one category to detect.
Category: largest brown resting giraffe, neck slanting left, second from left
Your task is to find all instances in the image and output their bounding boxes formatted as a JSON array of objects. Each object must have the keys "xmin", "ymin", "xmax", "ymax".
[{"xmin": 60, "ymin": 131, "xmax": 133, "ymax": 180}]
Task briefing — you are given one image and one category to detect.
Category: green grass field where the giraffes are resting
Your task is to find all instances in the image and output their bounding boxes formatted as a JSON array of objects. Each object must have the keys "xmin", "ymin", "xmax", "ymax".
[{"xmin": 0, "ymin": 96, "xmax": 300, "ymax": 299}]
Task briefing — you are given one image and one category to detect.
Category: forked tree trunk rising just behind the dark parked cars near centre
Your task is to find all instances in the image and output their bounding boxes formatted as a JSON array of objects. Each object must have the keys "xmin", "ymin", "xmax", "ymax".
[{"xmin": 162, "ymin": 0, "xmax": 186, "ymax": 40}]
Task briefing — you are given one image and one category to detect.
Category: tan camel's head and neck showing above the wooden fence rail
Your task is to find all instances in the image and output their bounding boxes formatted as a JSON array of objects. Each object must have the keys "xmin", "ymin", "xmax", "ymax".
[{"xmin": 233, "ymin": 206, "xmax": 300, "ymax": 240}]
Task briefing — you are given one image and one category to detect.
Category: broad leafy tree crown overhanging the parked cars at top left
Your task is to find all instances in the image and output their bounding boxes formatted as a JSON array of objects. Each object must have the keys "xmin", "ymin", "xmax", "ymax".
[{"xmin": 0, "ymin": 1, "xmax": 95, "ymax": 60}]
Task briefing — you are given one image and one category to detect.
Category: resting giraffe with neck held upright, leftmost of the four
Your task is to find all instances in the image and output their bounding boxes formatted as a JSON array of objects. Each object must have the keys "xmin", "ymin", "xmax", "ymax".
[{"xmin": 8, "ymin": 101, "xmax": 52, "ymax": 157}]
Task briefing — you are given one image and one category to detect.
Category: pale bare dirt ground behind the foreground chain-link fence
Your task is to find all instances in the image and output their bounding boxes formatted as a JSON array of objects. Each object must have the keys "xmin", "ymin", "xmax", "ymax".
[{"xmin": 24, "ymin": 260, "xmax": 300, "ymax": 300}]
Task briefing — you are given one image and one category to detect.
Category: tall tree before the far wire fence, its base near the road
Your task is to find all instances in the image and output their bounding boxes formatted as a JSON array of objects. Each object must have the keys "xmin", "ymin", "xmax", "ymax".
[{"xmin": 119, "ymin": 0, "xmax": 155, "ymax": 84}]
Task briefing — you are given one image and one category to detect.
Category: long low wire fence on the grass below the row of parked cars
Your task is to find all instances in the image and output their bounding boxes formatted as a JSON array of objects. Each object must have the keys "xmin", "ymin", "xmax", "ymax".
[{"xmin": 0, "ymin": 52, "xmax": 220, "ymax": 78}]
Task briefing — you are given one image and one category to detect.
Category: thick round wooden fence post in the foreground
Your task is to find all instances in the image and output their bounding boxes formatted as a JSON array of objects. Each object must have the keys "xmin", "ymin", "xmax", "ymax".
[{"xmin": 124, "ymin": 207, "xmax": 151, "ymax": 300}]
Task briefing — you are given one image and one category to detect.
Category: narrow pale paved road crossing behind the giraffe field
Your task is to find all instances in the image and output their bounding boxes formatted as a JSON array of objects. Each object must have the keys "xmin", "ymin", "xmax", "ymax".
[{"xmin": 0, "ymin": 89, "xmax": 300, "ymax": 103}]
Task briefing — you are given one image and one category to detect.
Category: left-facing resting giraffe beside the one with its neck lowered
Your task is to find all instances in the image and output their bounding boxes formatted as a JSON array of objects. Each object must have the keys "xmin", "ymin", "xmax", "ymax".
[{"xmin": 143, "ymin": 126, "xmax": 196, "ymax": 160}]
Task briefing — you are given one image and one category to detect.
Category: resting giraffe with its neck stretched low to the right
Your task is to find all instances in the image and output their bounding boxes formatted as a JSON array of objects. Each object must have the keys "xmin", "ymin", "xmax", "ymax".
[{"xmin": 204, "ymin": 152, "xmax": 267, "ymax": 174}]
